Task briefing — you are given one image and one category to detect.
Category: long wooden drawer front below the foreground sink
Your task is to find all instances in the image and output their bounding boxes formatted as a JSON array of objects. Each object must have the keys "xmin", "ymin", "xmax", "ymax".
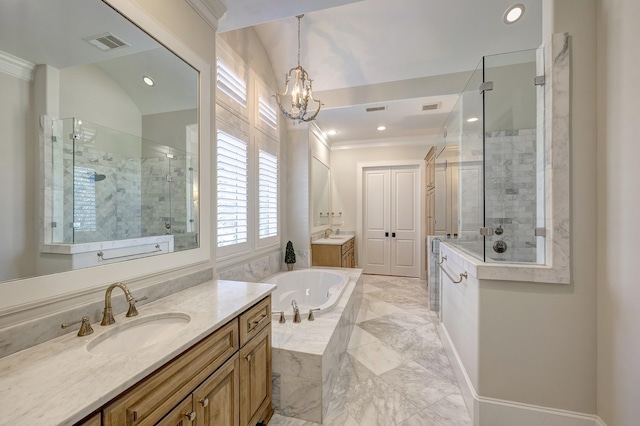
[{"xmin": 103, "ymin": 319, "xmax": 239, "ymax": 426}]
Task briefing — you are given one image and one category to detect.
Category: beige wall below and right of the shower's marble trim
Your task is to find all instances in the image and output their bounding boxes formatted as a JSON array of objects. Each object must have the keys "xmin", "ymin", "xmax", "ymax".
[{"xmin": 470, "ymin": 0, "xmax": 600, "ymax": 412}]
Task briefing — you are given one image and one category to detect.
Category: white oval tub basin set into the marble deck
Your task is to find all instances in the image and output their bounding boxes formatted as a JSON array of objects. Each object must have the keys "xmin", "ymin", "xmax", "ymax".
[{"xmin": 264, "ymin": 268, "xmax": 349, "ymax": 316}]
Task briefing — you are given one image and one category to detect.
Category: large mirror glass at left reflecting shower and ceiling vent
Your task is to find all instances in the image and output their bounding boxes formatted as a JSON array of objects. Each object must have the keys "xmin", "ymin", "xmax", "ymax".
[{"xmin": 0, "ymin": 0, "xmax": 199, "ymax": 281}]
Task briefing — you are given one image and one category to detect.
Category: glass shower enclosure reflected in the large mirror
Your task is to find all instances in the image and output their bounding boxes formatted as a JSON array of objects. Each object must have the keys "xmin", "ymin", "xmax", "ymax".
[{"xmin": 51, "ymin": 118, "xmax": 198, "ymax": 251}]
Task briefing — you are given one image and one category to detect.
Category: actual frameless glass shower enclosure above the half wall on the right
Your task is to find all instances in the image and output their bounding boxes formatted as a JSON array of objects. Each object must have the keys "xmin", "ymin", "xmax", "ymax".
[{"xmin": 436, "ymin": 49, "xmax": 545, "ymax": 264}]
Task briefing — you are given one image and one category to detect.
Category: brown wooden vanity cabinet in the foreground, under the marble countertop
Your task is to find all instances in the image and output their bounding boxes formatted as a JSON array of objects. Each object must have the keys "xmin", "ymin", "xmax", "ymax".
[{"xmin": 95, "ymin": 296, "xmax": 273, "ymax": 426}]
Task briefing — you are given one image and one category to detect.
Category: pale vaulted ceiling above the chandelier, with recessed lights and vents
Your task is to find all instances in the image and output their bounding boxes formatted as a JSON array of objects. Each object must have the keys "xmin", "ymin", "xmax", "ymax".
[{"xmin": 220, "ymin": 0, "xmax": 542, "ymax": 142}]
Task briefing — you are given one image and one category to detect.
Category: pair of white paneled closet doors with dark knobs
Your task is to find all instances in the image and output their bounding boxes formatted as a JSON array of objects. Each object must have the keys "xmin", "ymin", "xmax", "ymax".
[{"xmin": 363, "ymin": 167, "xmax": 420, "ymax": 277}]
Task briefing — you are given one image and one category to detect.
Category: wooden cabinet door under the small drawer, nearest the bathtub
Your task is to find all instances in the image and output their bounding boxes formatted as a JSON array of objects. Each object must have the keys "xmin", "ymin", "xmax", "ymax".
[{"xmin": 240, "ymin": 324, "xmax": 272, "ymax": 426}]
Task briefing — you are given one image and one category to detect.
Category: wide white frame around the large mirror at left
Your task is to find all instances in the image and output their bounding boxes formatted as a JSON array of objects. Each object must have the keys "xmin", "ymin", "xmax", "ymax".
[{"xmin": 0, "ymin": 0, "xmax": 215, "ymax": 327}]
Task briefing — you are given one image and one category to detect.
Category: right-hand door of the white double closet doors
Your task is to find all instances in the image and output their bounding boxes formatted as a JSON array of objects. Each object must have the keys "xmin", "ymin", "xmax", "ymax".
[{"xmin": 390, "ymin": 168, "xmax": 420, "ymax": 277}]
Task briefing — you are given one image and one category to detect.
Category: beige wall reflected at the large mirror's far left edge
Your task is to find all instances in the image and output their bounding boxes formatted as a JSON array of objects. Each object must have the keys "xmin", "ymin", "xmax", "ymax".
[{"xmin": 0, "ymin": 72, "xmax": 39, "ymax": 281}]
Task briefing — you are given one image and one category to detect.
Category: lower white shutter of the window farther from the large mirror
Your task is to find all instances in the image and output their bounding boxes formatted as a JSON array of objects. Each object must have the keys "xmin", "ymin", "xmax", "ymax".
[{"xmin": 258, "ymin": 150, "xmax": 278, "ymax": 240}]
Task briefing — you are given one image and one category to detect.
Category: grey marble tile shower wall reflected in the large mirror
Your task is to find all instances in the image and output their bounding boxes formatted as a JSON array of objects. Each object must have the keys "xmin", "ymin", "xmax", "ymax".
[{"xmin": 59, "ymin": 142, "xmax": 198, "ymax": 250}]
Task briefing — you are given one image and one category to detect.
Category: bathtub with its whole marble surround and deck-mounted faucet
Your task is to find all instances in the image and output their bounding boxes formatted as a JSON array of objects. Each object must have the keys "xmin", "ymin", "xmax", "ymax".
[{"xmin": 263, "ymin": 267, "xmax": 362, "ymax": 423}]
